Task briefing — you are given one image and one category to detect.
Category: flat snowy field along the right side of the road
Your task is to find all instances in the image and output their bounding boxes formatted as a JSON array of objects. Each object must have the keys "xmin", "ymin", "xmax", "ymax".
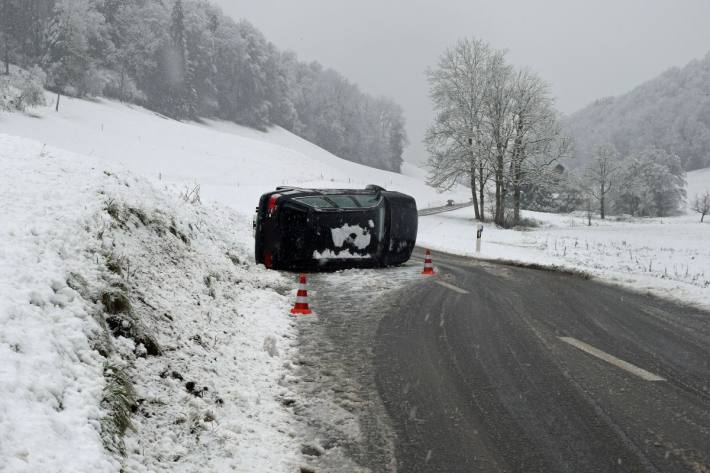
[{"xmin": 417, "ymin": 194, "xmax": 710, "ymax": 308}]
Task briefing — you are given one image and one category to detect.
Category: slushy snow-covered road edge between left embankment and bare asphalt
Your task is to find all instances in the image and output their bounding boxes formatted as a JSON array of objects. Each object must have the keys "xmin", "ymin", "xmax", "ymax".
[{"xmin": 290, "ymin": 261, "xmax": 424, "ymax": 472}]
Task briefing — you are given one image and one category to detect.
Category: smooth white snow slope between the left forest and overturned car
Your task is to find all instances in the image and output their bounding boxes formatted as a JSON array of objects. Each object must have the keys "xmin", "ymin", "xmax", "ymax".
[{"xmin": 0, "ymin": 93, "xmax": 467, "ymax": 212}]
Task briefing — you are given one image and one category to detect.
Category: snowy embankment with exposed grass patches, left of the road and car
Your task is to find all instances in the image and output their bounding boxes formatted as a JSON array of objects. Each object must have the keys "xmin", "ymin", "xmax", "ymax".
[{"xmin": 0, "ymin": 135, "xmax": 298, "ymax": 473}]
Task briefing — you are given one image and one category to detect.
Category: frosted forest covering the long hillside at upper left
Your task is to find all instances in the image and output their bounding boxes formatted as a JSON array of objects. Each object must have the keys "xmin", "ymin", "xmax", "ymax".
[{"xmin": 0, "ymin": 0, "xmax": 407, "ymax": 172}]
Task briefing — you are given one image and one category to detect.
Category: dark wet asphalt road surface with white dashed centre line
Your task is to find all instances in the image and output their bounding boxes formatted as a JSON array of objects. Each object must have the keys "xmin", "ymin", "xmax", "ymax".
[{"xmin": 373, "ymin": 249, "xmax": 710, "ymax": 473}]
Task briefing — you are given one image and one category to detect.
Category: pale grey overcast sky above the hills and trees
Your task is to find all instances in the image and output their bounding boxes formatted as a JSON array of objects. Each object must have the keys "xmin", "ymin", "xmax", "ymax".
[{"xmin": 213, "ymin": 0, "xmax": 710, "ymax": 162}]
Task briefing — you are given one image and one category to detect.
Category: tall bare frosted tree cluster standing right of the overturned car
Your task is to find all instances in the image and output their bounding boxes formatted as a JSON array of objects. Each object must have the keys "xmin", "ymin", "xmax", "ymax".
[{"xmin": 425, "ymin": 40, "xmax": 568, "ymax": 226}]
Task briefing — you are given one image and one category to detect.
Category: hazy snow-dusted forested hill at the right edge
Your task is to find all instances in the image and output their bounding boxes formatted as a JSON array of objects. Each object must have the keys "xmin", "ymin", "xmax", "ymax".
[{"xmin": 563, "ymin": 55, "xmax": 710, "ymax": 171}]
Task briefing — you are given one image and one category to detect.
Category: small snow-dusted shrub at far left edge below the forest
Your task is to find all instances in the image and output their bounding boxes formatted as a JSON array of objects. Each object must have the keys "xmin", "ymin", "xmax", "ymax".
[{"xmin": 0, "ymin": 67, "xmax": 46, "ymax": 112}]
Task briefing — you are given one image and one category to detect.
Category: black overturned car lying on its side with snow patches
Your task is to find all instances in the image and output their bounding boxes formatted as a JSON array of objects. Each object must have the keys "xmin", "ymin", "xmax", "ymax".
[{"xmin": 254, "ymin": 185, "xmax": 417, "ymax": 270}]
